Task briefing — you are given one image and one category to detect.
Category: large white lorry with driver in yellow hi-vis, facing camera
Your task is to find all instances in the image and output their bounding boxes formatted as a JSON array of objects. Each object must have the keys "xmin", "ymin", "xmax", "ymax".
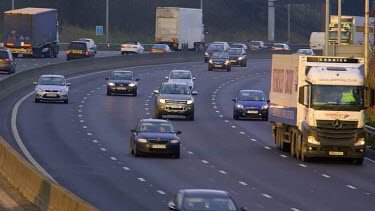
[{"xmin": 269, "ymin": 54, "xmax": 374, "ymax": 164}]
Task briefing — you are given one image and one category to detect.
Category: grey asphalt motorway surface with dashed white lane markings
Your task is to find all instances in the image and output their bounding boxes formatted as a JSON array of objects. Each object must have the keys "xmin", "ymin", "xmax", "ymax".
[{"xmin": 0, "ymin": 52, "xmax": 375, "ymax": 211}]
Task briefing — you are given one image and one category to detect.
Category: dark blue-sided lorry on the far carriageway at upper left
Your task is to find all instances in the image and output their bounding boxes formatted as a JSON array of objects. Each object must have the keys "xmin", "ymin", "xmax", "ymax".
[{"xmin": 4, "ymin": 7, "xmax": 59, "ymax": 58}]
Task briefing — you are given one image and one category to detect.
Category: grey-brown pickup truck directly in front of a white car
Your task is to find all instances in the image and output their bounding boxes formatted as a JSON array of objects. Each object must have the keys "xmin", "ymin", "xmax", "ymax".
[{"xmin": 154, "ymin": 82, "xmax": 197, "ymax": 120}]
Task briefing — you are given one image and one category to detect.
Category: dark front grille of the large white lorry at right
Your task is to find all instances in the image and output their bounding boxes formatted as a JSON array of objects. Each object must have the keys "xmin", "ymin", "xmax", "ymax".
[{"xmin": 317, "ymin": 120, "xmax": 358, "ymax": 143}]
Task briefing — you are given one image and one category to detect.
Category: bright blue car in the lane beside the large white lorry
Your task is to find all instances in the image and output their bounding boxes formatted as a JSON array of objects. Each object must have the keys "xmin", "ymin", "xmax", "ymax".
[{"xmin": 233, "ymin": 90, "xmax": 270, "ymax": 120}]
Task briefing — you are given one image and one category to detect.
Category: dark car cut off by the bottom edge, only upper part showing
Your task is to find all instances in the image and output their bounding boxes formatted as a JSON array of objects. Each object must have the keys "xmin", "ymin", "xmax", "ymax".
[{"xmin": 168, "ymin": 189, "xmax": 247, "ymax": 211}]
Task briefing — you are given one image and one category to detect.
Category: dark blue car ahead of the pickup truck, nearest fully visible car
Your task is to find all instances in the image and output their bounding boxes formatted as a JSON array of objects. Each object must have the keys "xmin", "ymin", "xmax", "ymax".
[{"xmin": 130, "ymin": 119, "xmax": 181, "ymax": 158}]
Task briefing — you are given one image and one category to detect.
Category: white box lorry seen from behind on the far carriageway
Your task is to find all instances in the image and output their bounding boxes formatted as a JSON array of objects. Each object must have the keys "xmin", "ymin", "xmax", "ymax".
[{"xmin": 155, "ymin": 7, "xmax": 204, "ymax": 50}]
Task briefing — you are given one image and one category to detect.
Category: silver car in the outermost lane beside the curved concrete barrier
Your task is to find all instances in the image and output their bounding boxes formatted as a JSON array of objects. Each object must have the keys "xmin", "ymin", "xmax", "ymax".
[{"xmin": 34, "ymin": 75, "xmax": 70, "ymax": 103}]
